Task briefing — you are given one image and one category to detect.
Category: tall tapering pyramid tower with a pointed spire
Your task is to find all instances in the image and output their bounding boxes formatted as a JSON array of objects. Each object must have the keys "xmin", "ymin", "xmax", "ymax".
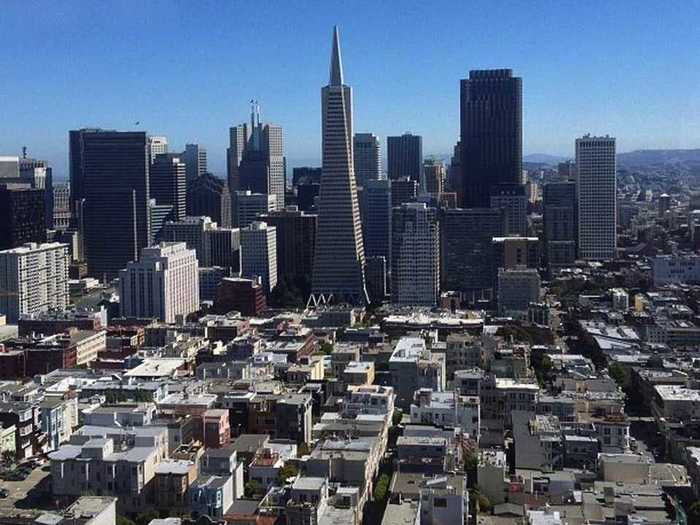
[{"xmin": 309, "ymin": 27, "xmax": 368, "ymax": 304}]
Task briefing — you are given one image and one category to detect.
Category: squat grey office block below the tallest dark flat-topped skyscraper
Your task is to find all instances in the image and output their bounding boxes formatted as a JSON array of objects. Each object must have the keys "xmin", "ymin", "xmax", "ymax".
[{"xmin": 497, "ymin": 268, "xmax": 542, "ymax": 318}]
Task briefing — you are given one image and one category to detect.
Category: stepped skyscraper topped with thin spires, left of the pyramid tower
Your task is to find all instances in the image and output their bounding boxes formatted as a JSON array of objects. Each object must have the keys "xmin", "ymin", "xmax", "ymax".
[{"xmin": 228, "ymin": 101, "xmax": 286, "ymax": 209}]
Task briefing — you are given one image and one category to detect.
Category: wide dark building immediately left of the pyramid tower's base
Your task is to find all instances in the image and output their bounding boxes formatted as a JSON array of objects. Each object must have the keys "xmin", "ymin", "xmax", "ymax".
[{"xmin": 260, "ymin": 206, "xmax": 318, "ymax": 293}]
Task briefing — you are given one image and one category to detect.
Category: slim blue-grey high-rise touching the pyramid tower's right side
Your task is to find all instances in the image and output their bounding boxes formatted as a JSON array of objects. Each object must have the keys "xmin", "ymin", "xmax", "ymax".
[{"xmin": 360, "ymin": 179, "xmax": 392, "ymax": 271}]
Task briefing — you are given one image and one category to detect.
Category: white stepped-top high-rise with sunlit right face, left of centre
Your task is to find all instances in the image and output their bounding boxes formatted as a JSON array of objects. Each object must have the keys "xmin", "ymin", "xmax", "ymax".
[{"xmin": 119, "ymin": 242, "xmax": 199, "ymax": 323}]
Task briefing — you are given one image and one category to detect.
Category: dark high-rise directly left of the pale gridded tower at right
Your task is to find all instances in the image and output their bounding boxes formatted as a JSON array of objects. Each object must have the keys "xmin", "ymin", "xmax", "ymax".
[{"xmin": 543, "ymin": 182, "xmax": 577, "ymax": 271}]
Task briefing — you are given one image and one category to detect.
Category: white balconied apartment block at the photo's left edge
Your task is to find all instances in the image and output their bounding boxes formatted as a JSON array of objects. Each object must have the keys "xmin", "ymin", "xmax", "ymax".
[{"xmin": 0, "ymin": 243, "xmax": 70, "ymax": 323}]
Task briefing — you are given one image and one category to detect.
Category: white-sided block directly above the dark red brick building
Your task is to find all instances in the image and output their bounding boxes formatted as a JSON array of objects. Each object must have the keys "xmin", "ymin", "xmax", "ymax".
[{"xmin": 240, "ymin": 221, "xmax": 277, "ymax": 293}]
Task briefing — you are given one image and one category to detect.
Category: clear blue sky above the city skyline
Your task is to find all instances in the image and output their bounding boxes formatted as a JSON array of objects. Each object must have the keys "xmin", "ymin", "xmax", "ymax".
[{"xmin": 0, "ymin": 0, "xmax": 700, "ymax": 176}]
